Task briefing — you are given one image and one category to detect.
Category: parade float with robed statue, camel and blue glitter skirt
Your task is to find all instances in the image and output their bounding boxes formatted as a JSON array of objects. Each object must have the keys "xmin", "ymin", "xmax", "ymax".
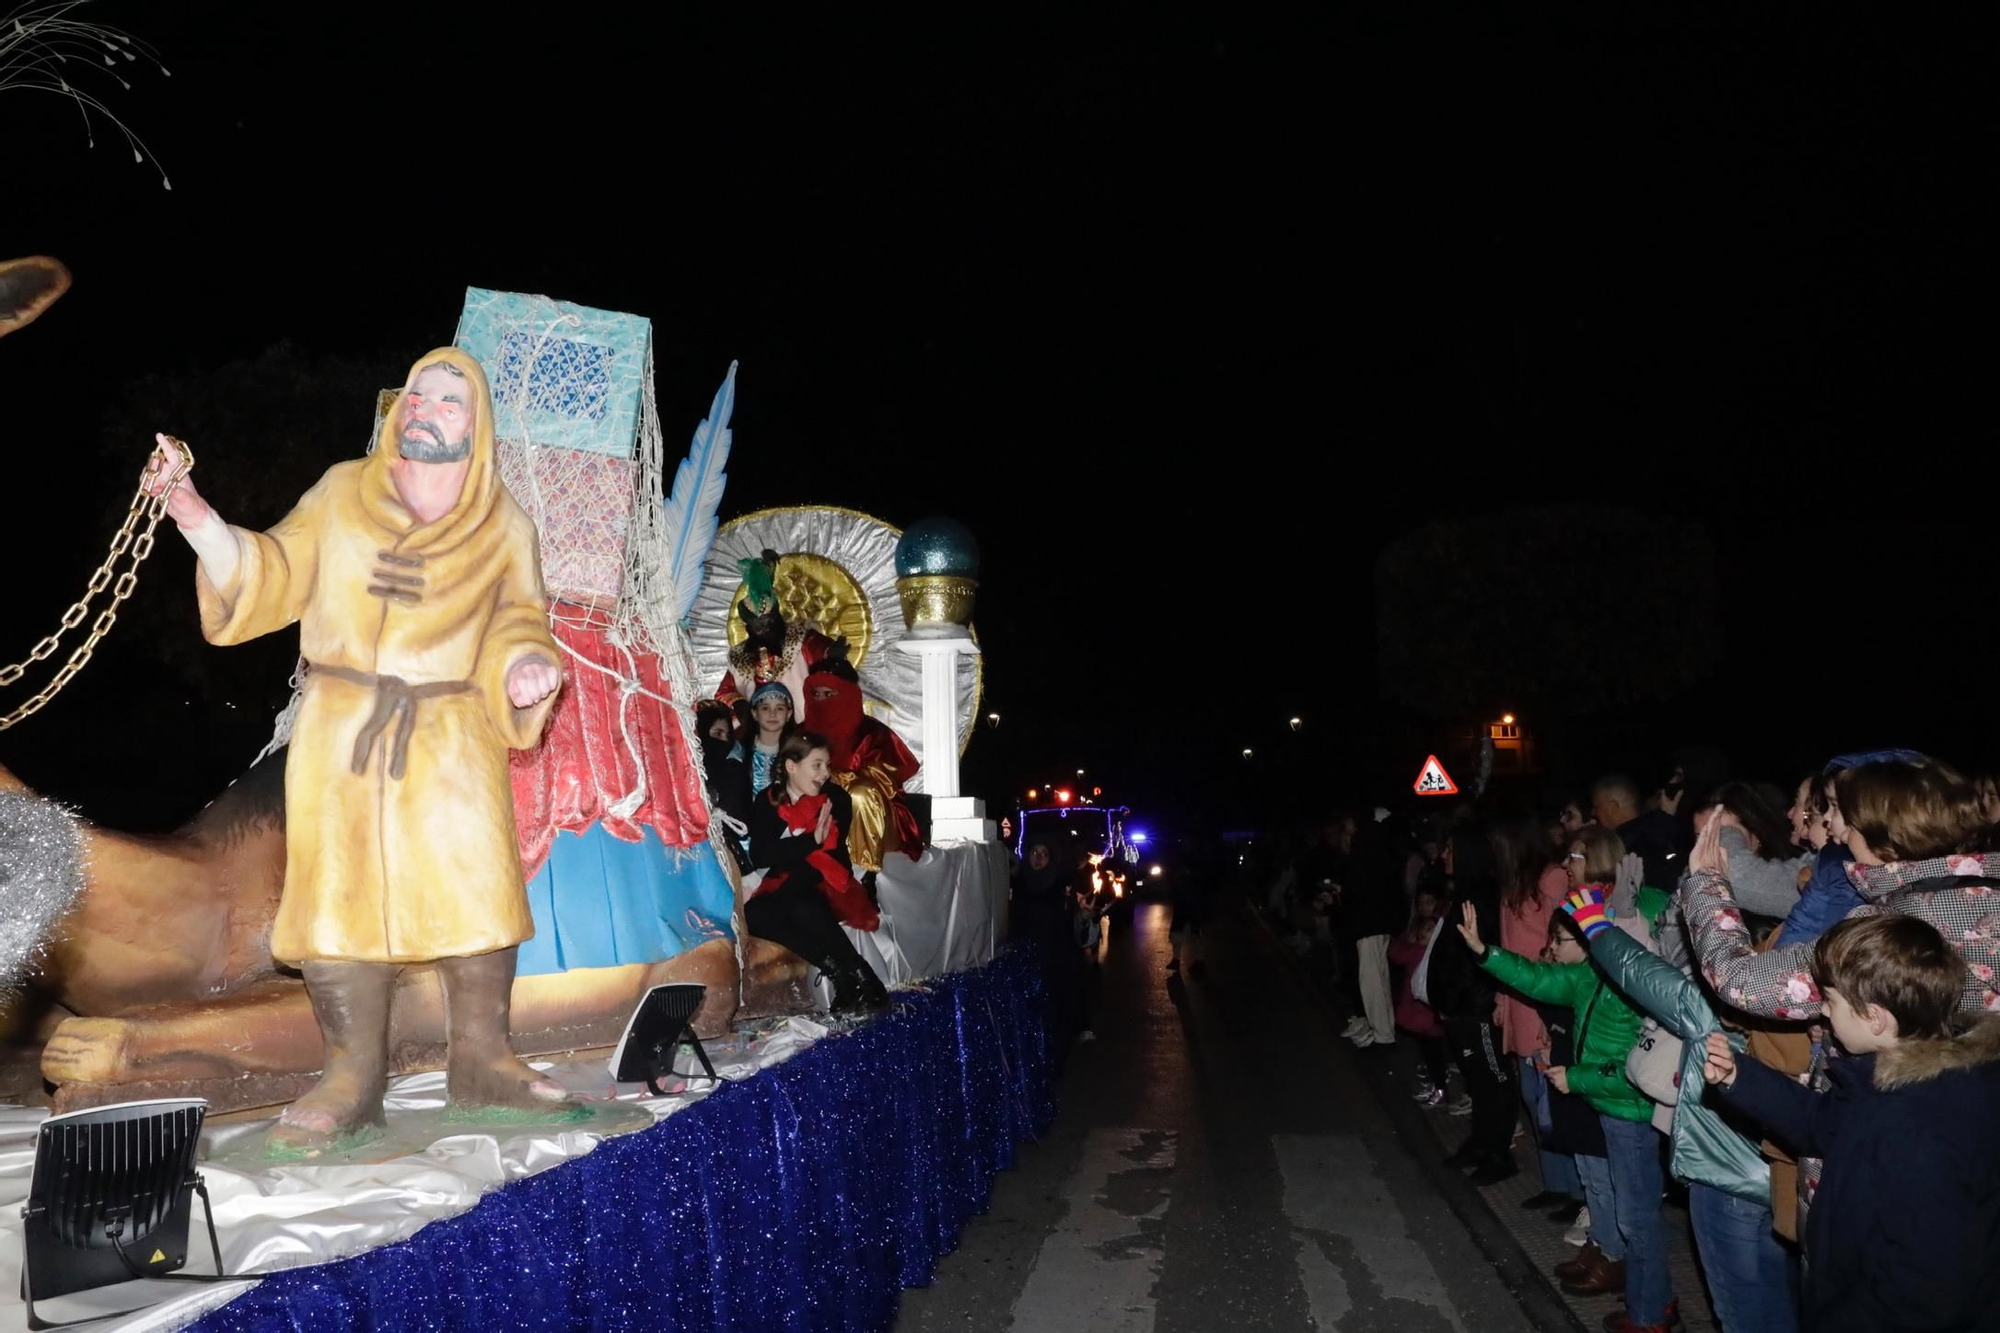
[{"xmin": 0, "ymin": 278, "xmax": 1050, "ymax": 1329}]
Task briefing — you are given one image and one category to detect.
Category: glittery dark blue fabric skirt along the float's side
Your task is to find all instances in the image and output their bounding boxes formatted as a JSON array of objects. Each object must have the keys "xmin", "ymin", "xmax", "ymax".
[{"xmin": 194, "ymin": 949, "xmax": 1054, "ymax": 1333}]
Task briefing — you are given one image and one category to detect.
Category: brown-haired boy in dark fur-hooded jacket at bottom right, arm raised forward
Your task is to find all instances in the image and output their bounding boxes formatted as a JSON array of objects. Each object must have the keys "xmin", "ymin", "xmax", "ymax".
[{"xmin": 1702, "ymin": 915, "xmax": 2000, "ymax": 1333}]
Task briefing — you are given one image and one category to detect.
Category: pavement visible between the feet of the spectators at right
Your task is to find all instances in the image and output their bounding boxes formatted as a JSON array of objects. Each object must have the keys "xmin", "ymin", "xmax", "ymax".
[{"xmin": 1274, "ymin": 920, "xmax": 1720, "ymax": 1333}]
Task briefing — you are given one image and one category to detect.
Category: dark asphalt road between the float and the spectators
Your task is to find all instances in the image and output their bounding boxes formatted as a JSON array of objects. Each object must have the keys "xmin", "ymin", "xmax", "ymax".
[{"xmin": 896, "ymin": 892, "xmax": 1560, "ymax": 1333}]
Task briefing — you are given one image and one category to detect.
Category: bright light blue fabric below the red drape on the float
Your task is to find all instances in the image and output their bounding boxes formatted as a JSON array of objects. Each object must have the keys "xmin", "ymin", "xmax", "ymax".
[{"xmin": 514, "ymin": 825, "xmax": 736, "ymax": 977}]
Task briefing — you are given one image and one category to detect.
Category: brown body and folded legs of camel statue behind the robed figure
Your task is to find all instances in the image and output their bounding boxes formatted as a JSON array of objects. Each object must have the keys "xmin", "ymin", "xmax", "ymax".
[{"xmin": 0, "ymin": 749, "xmax": 812, "ymax": 1111}]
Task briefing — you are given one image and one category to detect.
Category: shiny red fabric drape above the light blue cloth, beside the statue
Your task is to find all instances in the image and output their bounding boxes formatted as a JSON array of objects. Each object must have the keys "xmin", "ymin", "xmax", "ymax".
[{"xmin": 510, "ymin": 606, "xmax": 708, "ymax": 879}]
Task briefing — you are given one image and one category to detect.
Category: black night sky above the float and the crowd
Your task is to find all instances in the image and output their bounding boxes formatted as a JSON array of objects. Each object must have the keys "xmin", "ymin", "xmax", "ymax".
[{"xmin": 0, "ymin": 0, "xmax": 2000, "ymax": 827}]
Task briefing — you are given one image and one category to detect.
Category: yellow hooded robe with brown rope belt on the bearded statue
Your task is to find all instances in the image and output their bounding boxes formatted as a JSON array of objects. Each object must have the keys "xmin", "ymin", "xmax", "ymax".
[{"xmin": 196, "ymin": 348, "xmax": 562, "ymax": 963}]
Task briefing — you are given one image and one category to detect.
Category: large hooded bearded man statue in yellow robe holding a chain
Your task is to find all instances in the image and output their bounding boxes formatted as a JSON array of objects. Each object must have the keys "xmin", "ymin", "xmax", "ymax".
[{"xmin": 152, "ymin": 348, "xmax": 564, "ymax": 1151}]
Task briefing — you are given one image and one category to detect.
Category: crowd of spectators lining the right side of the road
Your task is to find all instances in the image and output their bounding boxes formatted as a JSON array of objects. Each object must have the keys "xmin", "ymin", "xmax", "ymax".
[{"xmin": 1266, "ymin": 751, "xmax": 2000, "ymax": 1333}]
